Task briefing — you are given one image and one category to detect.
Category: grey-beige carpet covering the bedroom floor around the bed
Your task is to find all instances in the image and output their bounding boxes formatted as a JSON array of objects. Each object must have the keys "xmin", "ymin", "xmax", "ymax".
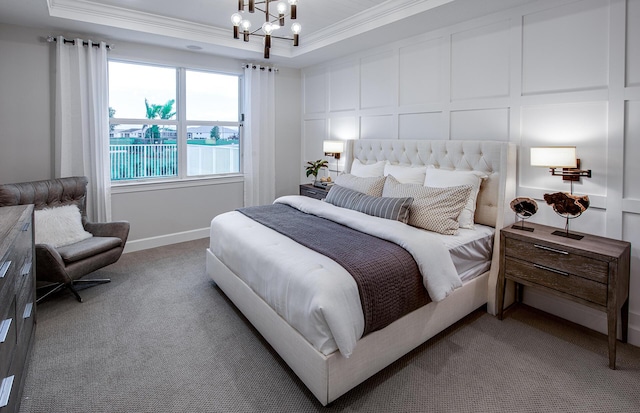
[{"xmin": 20, "ymin": 240, "xmax": 640, "ymax": 413}]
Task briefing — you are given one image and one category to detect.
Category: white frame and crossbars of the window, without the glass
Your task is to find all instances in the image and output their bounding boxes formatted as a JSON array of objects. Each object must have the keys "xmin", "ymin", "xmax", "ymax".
[{"xmin": 107, "ymin": 57, "xmax": 244, "ymax": 187}]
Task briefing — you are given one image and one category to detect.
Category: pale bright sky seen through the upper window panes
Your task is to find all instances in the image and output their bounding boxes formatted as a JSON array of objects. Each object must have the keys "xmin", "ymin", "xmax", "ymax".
[{"xmin": 109, "ymin": 61, "xmax": 239, "ymax": 122}]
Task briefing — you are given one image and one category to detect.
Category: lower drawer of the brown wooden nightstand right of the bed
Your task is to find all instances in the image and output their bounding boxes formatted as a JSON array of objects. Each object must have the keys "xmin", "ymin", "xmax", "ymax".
[{"xmin": 505, "ymin": 257, "xmax": 607, "ymax": 306}]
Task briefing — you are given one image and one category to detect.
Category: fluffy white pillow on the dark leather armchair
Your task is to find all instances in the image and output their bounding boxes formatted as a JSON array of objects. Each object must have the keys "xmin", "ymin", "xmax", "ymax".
[{"xmin": 34, "ymin": 205, "xmax": 93, "ymax": 248}]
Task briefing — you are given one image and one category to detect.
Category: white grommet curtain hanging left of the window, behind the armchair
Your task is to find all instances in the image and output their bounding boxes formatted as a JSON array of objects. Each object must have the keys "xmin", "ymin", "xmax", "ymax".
[{"xmin": 54, "ymin": 36, "xmax": 111, "ymax": 222}]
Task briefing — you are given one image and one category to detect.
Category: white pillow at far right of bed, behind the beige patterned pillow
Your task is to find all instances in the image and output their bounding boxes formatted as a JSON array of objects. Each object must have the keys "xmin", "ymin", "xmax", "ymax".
[{"xmin": 424, "ymin": 165, "xmax": 487, "ymax": 229}]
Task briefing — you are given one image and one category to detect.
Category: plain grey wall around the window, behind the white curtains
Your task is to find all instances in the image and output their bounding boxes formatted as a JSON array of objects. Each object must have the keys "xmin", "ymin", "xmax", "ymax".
[{"xmin": 0, "ymin": 24, "xmax": 302, "ymax": 251}]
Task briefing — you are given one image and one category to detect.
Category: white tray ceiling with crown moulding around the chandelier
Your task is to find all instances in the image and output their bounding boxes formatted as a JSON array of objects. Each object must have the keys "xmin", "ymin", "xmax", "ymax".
[{"xmin": 0, "ymin": 0, "xmax": 538, "ymax": 68}]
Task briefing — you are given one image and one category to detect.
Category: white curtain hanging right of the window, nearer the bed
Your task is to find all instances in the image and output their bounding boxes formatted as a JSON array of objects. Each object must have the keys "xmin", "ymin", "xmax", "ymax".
[{"xmin": 243, "ymin": 64, "xmax": 276, "ymax": 206}]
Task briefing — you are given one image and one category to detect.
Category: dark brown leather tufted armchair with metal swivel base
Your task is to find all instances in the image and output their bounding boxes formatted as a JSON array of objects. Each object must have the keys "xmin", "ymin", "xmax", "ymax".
[{"xmin": 0, "ymin": 176, "xmax": 129, "ymax": 302}]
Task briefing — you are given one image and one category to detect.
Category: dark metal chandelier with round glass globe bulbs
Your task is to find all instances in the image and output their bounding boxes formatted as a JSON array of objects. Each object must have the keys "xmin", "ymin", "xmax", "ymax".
[{"xmin": 231, "ymin": 0, "xmax": 302, "ymax": 59}]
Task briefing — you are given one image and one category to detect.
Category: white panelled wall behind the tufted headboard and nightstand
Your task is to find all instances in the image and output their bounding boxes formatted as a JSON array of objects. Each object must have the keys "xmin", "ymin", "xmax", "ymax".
[{"xmin": 301, "ymin": 0, "xmax": 640, "ymax": 345}]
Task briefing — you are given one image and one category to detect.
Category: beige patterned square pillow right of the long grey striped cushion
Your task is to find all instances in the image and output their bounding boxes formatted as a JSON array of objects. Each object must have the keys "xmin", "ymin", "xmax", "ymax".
[{"xmin": 382, "ymin": 176, "xmax": 471, "ymax": 235}]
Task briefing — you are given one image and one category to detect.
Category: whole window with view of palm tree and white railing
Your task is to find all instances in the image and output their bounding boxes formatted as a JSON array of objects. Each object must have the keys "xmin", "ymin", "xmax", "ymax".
[{"xmin": 109, "ymin": 60, "xmax": 240, "ymax": 181}]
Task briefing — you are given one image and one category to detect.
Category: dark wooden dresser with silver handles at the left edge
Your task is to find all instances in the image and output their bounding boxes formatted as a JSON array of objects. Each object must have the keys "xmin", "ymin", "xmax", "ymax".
[{"xmin": 0, "ymin": 205, "xmax": 36, "ymax": 413}]
